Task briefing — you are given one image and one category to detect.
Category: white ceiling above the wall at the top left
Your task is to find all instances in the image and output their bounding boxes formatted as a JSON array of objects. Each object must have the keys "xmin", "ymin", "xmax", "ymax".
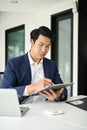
[{"xmin": 0, "ymin": 0, "xmax": 65, "ymax": 13}]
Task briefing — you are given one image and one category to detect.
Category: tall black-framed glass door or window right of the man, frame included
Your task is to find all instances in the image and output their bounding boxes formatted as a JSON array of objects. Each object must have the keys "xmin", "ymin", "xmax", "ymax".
[{"xmin": 51, "ymin": 10, "xmax": 73, "ymax": 96}]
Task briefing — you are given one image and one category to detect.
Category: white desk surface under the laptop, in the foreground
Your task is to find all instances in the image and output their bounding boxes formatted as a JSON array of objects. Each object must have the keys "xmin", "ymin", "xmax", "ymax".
[{"xmin": 0, "ymin": 95, "xmax": 87, "ymax": 130}]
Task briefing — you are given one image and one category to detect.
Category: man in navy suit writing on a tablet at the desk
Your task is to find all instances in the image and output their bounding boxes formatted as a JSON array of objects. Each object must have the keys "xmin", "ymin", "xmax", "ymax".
[{"xmin": 2, "ymin": 26, "xmax": 67, "ymax": 103}]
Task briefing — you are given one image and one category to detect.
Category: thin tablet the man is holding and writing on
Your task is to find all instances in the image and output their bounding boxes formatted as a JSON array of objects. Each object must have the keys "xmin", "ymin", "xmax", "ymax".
[{"xmin": 31, "ymin": 82, "xmax": 74, "ymax": 96}]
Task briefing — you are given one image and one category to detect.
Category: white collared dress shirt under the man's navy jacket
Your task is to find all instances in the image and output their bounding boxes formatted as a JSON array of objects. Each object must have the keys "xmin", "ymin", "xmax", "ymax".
[{"xmin": 24, "ymin": 53, "xmax": 46, "ymax": 102}]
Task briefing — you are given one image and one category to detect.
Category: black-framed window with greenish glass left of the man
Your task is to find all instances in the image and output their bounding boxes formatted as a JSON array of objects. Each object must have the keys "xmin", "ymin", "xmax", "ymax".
[{"xmin": 5, "ymin": 25, "xmax": 25, "ymax": 64}]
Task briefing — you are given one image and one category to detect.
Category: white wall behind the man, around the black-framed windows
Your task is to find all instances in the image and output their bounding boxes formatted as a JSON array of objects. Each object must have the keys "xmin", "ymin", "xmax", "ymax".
[{"xmin": 0, "ymin": 0, "xmax": 78, "ymax": 95}]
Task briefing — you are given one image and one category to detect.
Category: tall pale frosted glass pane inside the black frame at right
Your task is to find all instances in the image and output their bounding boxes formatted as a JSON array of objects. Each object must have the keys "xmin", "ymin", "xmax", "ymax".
[{"xmin": 58, "ymin": 18, "xmax": 72, "ymax": 96}]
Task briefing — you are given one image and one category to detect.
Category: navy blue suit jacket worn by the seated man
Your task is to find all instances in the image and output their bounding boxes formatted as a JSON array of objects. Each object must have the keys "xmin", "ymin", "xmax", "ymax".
[{"xmin": 2, "ymin": 53, "xmax": 67, "ymax": 102}]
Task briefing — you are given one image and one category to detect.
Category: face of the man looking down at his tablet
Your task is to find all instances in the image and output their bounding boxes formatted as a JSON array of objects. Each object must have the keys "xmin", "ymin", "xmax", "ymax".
[{"xmin": 31, "ymin": 35, "xmax": 51, "ymax": 61}]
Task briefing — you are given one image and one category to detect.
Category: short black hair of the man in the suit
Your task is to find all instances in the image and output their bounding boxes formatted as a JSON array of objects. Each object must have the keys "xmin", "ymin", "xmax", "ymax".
[{"xmin": 30, "ymin": 26, "xmax": 54, "ymax": 43}]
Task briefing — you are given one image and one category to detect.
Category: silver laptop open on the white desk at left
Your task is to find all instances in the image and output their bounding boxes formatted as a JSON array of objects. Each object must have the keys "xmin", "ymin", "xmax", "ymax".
[{"xmin": 0, "ymin": 88, "xmax": 29, "ymax": 117}]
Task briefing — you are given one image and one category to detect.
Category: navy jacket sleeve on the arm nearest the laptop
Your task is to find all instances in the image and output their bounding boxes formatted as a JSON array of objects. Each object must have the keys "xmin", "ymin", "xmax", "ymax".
[{"xmin": 1, "ymin": 60, "xmax": 26, "ymax": 102}]
